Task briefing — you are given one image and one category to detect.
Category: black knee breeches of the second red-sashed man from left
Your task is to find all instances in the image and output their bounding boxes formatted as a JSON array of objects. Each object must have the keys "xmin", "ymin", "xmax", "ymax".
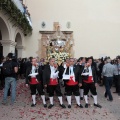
[{"xmin": 47, "ymin": 84, "xmax": 62, "ymax": 97}]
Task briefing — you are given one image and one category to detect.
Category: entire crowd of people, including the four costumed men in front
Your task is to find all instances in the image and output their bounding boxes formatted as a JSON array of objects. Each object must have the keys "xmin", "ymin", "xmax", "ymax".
[{"xmin": 0, "ymin": 53, "xmax": 120, "ymax": 109}]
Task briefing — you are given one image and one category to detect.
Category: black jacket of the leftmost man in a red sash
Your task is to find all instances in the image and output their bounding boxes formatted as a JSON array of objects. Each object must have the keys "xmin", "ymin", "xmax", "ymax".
[{"xmin": 26, "ymin": 65, "xmax": 42, "ymax": 84}]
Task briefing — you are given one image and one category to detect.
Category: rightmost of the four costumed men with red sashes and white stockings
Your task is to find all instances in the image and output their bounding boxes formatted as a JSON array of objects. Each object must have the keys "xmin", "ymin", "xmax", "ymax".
[{"xmin": 80, "ymin": 58, "xmax": 101, "ymax": 108}]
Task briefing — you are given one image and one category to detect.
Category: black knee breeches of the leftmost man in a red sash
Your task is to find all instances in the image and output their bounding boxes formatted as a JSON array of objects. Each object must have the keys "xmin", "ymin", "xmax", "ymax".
[{"xmin": 30, "ymin": 83, "xmax": 44, "ymax": 95}]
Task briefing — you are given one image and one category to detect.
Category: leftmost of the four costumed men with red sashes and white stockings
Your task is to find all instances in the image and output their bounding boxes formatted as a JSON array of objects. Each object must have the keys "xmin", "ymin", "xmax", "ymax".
[{"xmin": 26, "ymin": 58, "xmax": 47, "ymax": 107}]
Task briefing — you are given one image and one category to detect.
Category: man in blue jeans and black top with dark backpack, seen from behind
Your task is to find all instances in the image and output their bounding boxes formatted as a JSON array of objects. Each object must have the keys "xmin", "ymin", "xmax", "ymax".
[{"xmin": 3, "ymin": 53, "xmax": 18, "ymax": 104}]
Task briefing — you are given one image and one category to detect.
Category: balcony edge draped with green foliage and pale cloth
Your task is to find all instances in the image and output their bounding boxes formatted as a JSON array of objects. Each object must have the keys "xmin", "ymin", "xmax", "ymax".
[{"xmin": 0, "ymin": 0, "xmax": 32, "ymax": 35}]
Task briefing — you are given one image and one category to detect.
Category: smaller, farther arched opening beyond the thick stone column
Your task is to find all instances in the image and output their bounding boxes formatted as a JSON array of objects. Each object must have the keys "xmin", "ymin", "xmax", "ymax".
[{"xmin": 15, "ymin": 33, "xmax": 22, "ymax": 58}]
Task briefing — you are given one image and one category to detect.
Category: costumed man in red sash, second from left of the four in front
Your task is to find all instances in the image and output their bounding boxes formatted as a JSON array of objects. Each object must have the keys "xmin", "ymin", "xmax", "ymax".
[{"xmin": 43, "ymin": 58, "xmax": 66, "ymax": 109}]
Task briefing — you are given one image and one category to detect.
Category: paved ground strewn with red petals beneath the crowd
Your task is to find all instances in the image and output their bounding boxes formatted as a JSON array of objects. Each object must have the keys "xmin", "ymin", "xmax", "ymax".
[{"xmin": 0, "ymin": 80, "xmax": 120, "ymax": 120}]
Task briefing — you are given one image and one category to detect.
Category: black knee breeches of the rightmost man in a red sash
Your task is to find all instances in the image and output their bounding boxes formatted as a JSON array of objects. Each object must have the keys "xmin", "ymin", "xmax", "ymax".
[{"xmin": 83, "ymin": 82, "xmax": 97, "ymax": 95}]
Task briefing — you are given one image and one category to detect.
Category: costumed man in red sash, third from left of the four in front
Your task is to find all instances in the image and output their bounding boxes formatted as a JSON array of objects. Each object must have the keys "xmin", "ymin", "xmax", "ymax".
[{"xmin": 63, "ymin": 58, "xmax": 83, "ymax": 108}]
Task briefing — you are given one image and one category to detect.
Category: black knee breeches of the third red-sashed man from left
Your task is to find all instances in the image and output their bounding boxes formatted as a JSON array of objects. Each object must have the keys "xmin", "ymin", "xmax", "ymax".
[{"xmin": 66, "ymin": 85, "xmax": 80, "ymax": 96}]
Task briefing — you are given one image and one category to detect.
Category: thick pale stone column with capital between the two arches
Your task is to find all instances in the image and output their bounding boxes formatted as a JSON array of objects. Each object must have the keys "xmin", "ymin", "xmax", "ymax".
[{"xmin": 0, "ymin": 40, "xmax": 16, "ymax": 57}]
